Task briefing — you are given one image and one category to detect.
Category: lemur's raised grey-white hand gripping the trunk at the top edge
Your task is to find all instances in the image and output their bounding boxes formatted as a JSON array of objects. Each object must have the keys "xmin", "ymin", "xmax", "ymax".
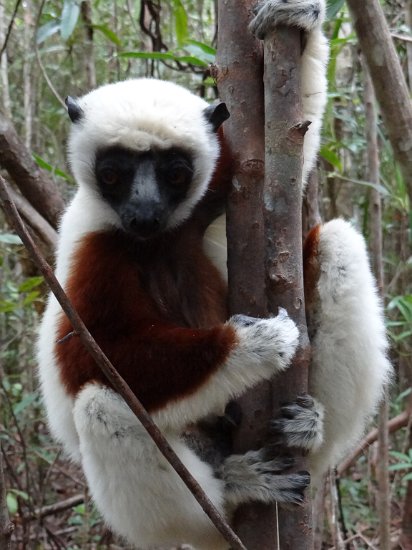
[{"xmin": 250, "ymin": 0, "xmax": 326, "ymax": 40}]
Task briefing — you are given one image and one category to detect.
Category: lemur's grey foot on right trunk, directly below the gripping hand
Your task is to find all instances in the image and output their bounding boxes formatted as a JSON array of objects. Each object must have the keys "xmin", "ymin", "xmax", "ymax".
[{"xmin": 270, "ymin": 395, "xmax": 323, "ymax": 451}]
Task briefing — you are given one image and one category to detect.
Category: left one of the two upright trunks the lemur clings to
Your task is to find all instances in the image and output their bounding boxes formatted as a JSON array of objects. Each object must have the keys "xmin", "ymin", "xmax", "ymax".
[{"xmin": 216, "ymin": 0, "xmax": 268, "ymax": 464}]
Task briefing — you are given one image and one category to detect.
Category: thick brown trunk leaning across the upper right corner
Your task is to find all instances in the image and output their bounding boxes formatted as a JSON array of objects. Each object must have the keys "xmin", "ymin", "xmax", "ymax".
[{"xmin": 347, "ymin": 0, "xmax": 412, "ymax": 205}]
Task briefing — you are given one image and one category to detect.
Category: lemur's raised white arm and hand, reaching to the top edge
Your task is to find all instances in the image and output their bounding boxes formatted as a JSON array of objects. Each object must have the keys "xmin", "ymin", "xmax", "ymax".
[{"xmin": 250, "ymin": 0, "xmax": 329, "ymax": 186}]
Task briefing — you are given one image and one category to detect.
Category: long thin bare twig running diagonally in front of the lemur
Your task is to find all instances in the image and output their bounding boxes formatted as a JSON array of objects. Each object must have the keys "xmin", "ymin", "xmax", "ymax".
[{"xmin": 0, "ymin": 176, "xmax": 246, "ymax": 550}]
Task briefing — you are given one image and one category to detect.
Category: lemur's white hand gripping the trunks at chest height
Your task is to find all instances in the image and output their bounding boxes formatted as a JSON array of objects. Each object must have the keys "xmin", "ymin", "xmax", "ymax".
[{"xmin": 228, "ymin": 308, "xmax": 299, "ymax": 378}]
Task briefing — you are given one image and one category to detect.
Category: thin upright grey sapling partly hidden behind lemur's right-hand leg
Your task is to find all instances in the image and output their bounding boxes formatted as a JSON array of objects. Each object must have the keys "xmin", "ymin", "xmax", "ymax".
[{"xmin": 363, "ymin": 63, "xmax": 390, "ymax": 548}]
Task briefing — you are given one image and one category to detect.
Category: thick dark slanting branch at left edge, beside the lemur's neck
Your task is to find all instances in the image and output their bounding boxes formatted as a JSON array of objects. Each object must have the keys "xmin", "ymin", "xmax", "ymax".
[{"xmin": 0, "ymin": 113, "xmax": 64, "ymax": 228}]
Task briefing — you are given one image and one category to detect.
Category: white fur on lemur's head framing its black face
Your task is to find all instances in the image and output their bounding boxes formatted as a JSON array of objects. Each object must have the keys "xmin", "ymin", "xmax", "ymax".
[{"xmin": 69, "ymin": 78, "xmax": 219, "ymax": 227}]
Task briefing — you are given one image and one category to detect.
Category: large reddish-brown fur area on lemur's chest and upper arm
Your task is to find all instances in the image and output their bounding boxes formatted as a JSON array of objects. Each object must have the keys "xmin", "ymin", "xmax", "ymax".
[{"xmin": 56, "ymin": 226, "xmax": 235, "ymax": 411}]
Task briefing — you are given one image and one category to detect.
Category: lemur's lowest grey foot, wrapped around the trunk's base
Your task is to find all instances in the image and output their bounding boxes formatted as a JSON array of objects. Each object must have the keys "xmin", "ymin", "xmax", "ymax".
[{"xmin": 221, "ymin": 449, "xmax": 310, "ymax": 507}]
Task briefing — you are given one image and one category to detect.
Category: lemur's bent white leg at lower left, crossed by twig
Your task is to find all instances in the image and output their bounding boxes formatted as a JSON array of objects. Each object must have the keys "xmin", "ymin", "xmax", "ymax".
[{"xmin": 74, "ymin": 384, "xmax": 228, "ymax": 550}]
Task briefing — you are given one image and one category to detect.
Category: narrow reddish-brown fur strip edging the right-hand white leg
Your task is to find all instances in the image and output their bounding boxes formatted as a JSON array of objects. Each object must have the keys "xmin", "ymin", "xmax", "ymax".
[{"xmin": 303, "ymin": 225, "xmax": 322, "ymax": 335}]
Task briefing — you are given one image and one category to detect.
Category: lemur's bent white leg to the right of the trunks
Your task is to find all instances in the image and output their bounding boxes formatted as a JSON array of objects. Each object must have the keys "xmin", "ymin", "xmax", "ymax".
[{"xmin": 304, "ymin": 220, "xmax": 391, "ymax": 484}]
